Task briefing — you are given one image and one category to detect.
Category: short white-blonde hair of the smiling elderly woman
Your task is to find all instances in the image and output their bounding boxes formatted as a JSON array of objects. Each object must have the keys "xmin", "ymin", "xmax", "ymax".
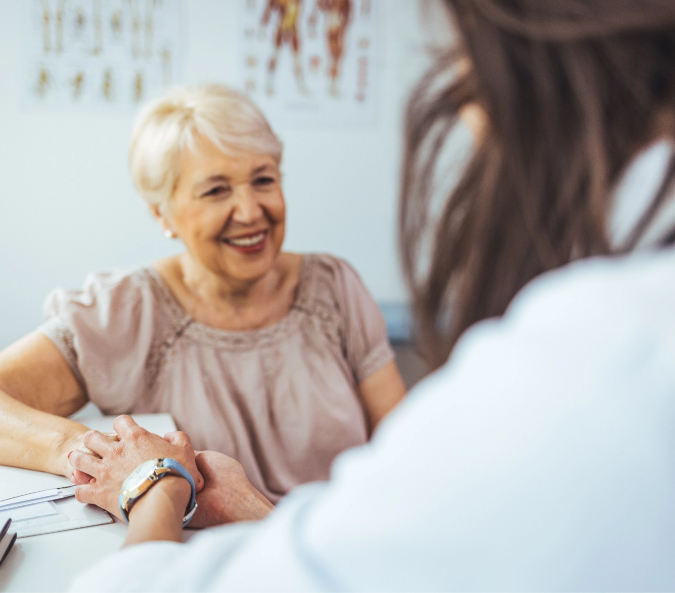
[{"xmin": 129, "ymin": 84, "xmax": 283, "ymax": 213}]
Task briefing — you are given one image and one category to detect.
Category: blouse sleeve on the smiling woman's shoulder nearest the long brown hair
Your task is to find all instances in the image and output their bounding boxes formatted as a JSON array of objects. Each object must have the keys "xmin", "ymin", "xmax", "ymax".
[{"xmin": 324, "ymin": 257, "xmax": 394, "ymax": 383}]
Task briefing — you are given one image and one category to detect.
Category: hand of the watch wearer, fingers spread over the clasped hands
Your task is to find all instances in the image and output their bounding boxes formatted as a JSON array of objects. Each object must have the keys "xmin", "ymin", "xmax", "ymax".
[{"xmin": 70, "ymin": 416, "xmax": 204, "ymax": 518}]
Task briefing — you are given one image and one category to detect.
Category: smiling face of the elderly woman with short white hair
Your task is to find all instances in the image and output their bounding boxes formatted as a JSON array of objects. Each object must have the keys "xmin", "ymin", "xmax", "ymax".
[{"xmin": 167, "ymin": 138, "xmax": 286, "ymax": 282}]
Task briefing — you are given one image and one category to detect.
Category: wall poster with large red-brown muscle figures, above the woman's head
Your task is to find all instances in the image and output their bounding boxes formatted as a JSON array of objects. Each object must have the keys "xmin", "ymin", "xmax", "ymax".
[{"xmin": 239, "ymin": 0, "xmax": 378, "ymax": 126}]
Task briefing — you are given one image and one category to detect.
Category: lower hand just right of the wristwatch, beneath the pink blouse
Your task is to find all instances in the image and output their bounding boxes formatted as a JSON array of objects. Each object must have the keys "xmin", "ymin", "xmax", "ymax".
[{"xmin": 190, "ymin": 451, "xmax": 274, "ymax": 527}]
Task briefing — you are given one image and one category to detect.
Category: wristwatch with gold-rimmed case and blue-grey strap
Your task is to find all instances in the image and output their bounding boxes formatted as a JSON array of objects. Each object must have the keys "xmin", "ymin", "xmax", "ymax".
[{"xmin": 119, "ymin": 457, "xmax": 197, "ymax": 527}]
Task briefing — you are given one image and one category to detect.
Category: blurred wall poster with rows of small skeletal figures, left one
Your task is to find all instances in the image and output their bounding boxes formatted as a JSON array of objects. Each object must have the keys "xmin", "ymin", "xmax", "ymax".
[{"xmin": 23, "ymin": 0, "xmax": 182, "ymax": 109}]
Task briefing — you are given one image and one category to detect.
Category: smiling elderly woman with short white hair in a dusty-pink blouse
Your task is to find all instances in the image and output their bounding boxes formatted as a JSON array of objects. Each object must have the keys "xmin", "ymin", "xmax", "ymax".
[{"xmin": 0, "ymin": 85, "xmax": 405, "ymax": 502}]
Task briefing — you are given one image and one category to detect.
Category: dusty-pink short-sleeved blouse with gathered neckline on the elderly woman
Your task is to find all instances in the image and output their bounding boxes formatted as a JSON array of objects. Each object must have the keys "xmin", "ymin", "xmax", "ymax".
[{"xmin": 40, "ymin": 254, "xmax": 394, "ymax": 502}]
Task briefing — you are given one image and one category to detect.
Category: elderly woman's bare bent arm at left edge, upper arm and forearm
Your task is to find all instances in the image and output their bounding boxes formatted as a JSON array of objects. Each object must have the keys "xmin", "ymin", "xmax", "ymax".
[{"xmin": 0, "ymin": 332, "xmax": 87, "ymax": 477}]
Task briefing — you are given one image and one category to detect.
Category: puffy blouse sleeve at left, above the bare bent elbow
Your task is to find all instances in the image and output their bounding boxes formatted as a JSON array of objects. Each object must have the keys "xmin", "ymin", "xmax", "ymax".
[{"xmin": 38, "ymin": 271, "xmax": 157, "ymax": 414}]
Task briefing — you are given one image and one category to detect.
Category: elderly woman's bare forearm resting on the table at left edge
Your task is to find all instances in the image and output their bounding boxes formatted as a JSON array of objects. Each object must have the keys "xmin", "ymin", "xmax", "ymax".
[{"xmin": 0, "ymin": 390, "xmax": 88, "ymax": 476}]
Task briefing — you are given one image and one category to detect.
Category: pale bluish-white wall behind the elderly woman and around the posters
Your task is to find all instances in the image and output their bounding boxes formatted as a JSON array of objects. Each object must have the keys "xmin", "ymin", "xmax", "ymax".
[{"xmin": 0, "ymin": 0, "xmax": 430, "ymax": 347}]
